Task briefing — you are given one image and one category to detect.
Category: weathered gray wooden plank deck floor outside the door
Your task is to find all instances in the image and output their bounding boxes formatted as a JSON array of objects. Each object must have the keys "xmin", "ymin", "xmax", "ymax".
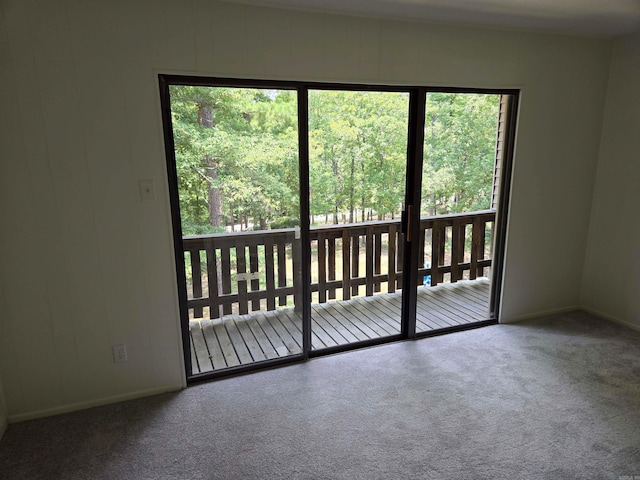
[{"xmin": 189, "ymin": 279, "xmax": 490, "ymax": 374}]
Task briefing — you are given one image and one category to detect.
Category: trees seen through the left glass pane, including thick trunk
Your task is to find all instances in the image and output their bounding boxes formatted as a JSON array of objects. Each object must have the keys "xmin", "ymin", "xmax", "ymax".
[{"xmin": 171, "ymin": 86, "xmax": 299, "ymax": 233}]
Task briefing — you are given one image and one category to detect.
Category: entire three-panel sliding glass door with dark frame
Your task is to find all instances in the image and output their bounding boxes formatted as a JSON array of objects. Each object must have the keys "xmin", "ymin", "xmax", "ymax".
[{"xmin": 160, "ymin": 75, "xmax": 517, "ymax": 379}]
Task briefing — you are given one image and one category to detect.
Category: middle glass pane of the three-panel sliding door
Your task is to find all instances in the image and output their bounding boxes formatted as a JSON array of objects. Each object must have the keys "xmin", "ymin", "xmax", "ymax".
[{"xmin": 309, "ymin": 90, "xmax": 409, "ymax": 350}]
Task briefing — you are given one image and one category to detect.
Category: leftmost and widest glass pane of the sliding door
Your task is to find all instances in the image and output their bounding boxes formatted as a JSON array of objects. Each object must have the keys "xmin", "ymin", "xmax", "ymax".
[{"xmin": 169, "ymin": 85, "xmax": 302, "ymax": 375}]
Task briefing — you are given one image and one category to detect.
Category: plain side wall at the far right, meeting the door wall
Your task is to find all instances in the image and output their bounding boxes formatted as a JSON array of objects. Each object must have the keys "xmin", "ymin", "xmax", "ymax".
[{"xmin": 581, "ymin": 34, "xmax": 640, "ymax": 329}]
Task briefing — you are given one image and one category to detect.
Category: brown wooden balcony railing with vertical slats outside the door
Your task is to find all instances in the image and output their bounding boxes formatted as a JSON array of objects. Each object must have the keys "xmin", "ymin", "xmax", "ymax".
[{"xmin": 183, "ymin": 210, "xmax": 495, "ymax": 318}]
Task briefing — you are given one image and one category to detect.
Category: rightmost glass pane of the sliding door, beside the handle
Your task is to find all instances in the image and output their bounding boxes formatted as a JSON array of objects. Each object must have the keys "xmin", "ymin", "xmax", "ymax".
[{"xmin": 416, "ymin": 92, "xmax": 507, "ymax": 332}]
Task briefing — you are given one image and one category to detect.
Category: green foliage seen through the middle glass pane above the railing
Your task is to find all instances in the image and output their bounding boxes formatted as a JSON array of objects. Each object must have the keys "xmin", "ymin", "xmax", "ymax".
[{"xmin": 309, "ymin": 90, "xmax": 409, "ymax": 221}]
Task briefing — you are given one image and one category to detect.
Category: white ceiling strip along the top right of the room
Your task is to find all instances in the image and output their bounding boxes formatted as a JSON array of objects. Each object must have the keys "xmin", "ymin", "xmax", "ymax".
[{"xmin": 227, "ymin": 0, "xmax": 640, "ymax": 37}]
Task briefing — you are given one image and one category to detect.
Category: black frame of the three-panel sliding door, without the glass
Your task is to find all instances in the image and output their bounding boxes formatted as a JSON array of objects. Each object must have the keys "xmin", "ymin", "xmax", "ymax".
[{"xmin": 158, "ymin": 74, "xmax": 520, "ymax": 383}]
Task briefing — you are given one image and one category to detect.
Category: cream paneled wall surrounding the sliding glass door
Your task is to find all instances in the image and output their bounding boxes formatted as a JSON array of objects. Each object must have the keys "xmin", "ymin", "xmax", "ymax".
[{"xmin": 0, "ymin": 0, "xmax": 610, "ymax": 420}]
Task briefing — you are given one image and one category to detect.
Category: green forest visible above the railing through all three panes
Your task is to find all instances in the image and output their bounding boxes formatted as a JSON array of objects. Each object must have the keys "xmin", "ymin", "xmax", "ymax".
[{"xmin": 170, "ymin": 85, "xmax": 500, "ymax": 235}]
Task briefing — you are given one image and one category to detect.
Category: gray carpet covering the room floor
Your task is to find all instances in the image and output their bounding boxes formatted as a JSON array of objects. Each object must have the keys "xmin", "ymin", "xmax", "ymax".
[{"xmin": 0, "ymin": 312, "xmax": 640, "ymax": 480}]
